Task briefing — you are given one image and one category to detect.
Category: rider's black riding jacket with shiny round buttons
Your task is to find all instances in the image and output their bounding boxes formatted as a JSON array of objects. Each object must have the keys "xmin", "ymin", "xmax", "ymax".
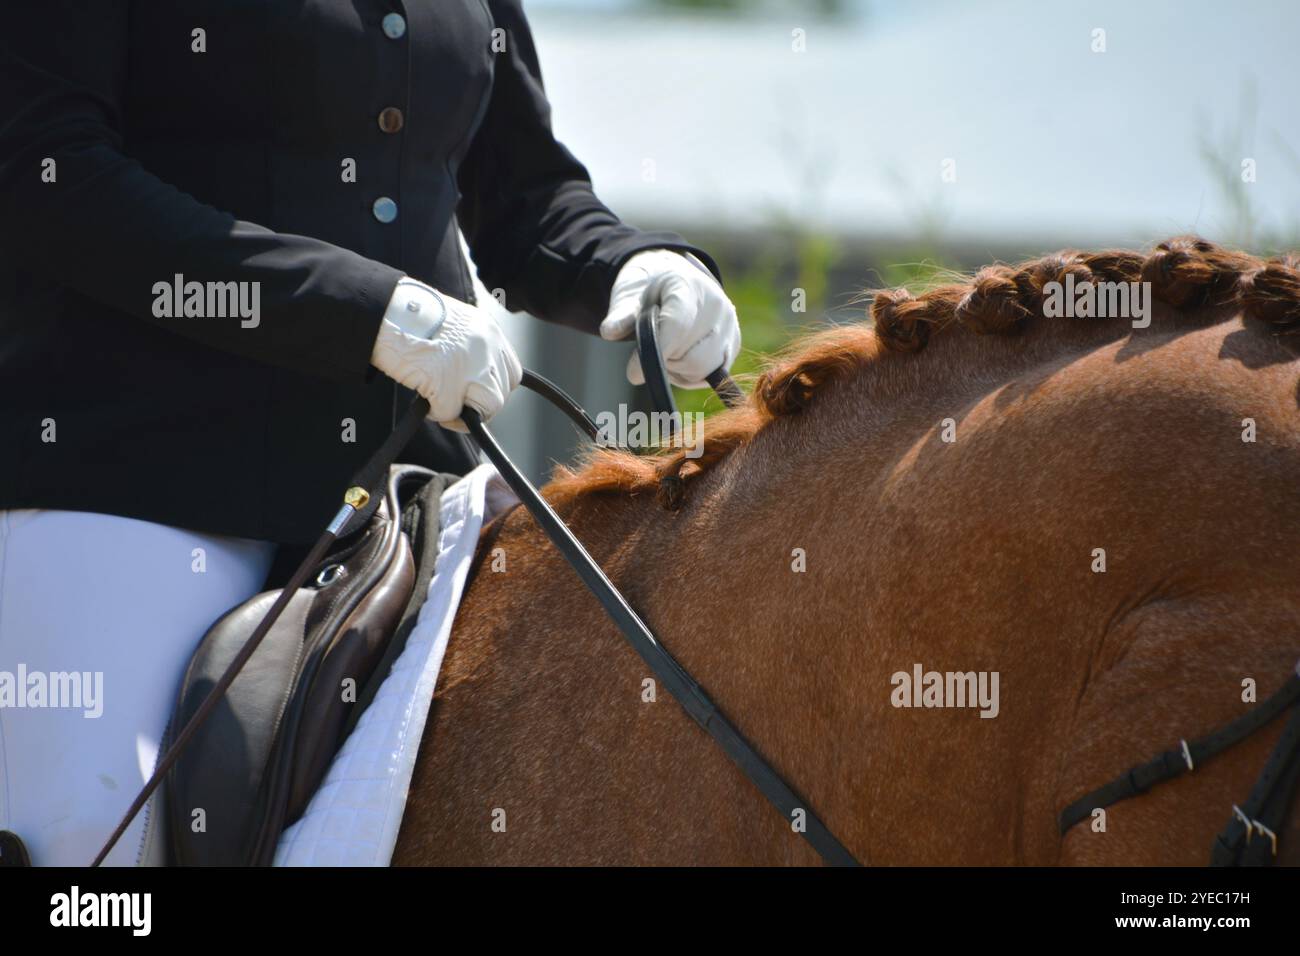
[{"xmin": 0, "ymin": 0, "xmax": 712, "ymax": 542}]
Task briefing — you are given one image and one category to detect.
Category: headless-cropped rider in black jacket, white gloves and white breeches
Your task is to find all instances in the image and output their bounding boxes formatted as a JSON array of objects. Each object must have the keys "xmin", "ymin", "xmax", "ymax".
[{"xmin": 0, "ymin": 0, "xmax": 740, "ymax": 865}]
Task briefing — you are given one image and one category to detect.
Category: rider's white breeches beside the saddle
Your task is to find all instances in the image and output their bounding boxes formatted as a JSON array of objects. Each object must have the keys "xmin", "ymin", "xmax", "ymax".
[{"xmin": 0, "ymin": 510, "xmax": 276, "ymax": 866}]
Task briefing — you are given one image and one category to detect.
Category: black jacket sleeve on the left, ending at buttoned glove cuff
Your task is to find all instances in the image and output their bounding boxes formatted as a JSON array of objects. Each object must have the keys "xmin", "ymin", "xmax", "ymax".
[{"xmin": 0, "ymin": 0, "xmax": 402, "ymax": 381}]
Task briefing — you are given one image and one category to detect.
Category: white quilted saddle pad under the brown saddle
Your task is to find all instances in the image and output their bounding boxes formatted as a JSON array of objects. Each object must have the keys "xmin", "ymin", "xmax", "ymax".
[{"xmin": 274, "ymin": 464, "xmax": 517, "ymax": 866}]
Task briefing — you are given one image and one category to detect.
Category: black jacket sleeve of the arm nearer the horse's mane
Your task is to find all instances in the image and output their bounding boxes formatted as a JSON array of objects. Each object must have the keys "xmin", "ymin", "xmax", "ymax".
[{"xmin": 458, "ymin": 0, "xmax": 720, "ymax": 333}]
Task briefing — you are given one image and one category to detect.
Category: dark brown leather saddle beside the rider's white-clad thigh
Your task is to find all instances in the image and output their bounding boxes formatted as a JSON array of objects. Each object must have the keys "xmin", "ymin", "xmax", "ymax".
[{"xmin": 166, "ymin": 466, "xmax": 455, "ymax": 866}]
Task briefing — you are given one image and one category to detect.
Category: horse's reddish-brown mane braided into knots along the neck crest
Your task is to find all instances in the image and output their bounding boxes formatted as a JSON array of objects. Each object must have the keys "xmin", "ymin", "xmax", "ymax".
[{"xmin": 543, "ymin": 237, "xmax": 1300, "ymax": 509}]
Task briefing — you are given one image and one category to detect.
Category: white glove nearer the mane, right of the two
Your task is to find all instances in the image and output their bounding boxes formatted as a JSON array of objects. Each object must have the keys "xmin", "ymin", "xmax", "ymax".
[{"xmin": 601, "ymin": 248, "xmax": 740, "ymax": 389}]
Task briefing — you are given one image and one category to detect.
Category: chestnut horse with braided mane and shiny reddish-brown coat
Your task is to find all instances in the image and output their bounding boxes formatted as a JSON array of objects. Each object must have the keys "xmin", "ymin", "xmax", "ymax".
[{"xmin": 394, "ymin": 239, "xmax": 1300, "ymax": 865}]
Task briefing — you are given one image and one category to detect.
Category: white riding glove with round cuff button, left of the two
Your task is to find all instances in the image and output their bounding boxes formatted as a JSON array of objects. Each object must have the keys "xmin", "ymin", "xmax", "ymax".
[{"xmin": 371, "ymin": 278, "xmax": 524, "ymax": 432}]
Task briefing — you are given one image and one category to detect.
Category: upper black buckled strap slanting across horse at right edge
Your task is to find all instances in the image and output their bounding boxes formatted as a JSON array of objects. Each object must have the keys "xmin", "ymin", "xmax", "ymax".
[{"xmin": 1060, "ymin": 675, "xmax": 1300, "ymax": 835}]
